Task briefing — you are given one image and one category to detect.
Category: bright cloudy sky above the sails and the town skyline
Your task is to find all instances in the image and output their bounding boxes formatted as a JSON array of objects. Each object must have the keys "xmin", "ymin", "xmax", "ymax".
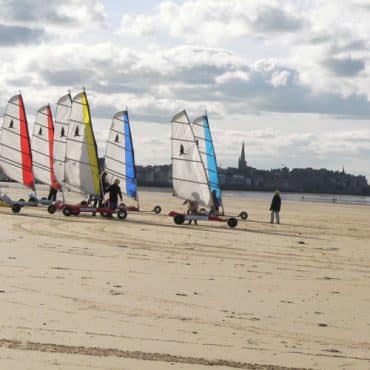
[{"xmin": 0, "ymin": 0, "xmax": 370, "ymax": 180}]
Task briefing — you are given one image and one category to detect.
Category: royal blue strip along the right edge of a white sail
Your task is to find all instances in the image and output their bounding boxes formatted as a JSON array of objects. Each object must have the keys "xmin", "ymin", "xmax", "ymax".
[{"xmin": 123, "ymin": 111, "xmax": 137, "ymax": 199}]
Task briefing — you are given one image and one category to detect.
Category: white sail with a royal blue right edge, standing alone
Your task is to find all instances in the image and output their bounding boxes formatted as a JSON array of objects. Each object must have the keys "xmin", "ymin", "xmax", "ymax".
[{"xmin": 105, "ymin": 111, "xmax": 137, "ymax": 199}]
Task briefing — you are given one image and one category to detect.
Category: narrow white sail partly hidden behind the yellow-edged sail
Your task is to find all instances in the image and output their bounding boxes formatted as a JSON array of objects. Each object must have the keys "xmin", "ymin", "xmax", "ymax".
[{"xmin": 54, "ymin": 93, "xmax": 72, "ymax": 184}]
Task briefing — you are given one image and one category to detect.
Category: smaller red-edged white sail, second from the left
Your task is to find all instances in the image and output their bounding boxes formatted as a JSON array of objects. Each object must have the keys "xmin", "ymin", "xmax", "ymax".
[{"xmin": 31, "ymin": 105, "xmax": 60, "ymax": 189}]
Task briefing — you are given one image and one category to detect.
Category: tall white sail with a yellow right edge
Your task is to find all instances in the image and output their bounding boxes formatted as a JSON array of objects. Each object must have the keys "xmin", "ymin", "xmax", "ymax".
[{"xmin": 65, "ymin": 91, "xmax": 102, "ymax": 197}]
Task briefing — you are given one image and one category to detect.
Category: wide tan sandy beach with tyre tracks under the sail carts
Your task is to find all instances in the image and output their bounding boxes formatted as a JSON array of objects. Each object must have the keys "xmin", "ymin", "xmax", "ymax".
[{"xmin": 0, "ymin": 185, "xmax": 370, "ymax": 370}]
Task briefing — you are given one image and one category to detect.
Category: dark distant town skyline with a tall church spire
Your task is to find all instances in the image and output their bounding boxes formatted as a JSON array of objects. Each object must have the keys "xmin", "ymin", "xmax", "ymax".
[{"xmin": 0, "ymin": 149, "xmax": 370, "ymax": 195}]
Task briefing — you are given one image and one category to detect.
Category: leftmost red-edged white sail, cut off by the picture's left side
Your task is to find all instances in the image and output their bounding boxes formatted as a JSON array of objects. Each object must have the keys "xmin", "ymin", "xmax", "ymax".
[{"xmin": 0, "ymin": 94, "xmax": 35, "ymax": 188}]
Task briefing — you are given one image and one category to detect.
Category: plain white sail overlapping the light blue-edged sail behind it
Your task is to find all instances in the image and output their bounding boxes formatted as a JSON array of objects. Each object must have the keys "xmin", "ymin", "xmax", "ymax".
[{"xmin": 171, "ymin": 111, "xmax": 213, "ymax": 208}]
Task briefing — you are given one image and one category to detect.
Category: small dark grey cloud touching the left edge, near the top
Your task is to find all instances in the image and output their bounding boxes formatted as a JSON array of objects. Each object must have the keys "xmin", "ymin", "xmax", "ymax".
[{"xmin": 0, "ymin": 24, "xmax": 45, "ymax": 47}]
